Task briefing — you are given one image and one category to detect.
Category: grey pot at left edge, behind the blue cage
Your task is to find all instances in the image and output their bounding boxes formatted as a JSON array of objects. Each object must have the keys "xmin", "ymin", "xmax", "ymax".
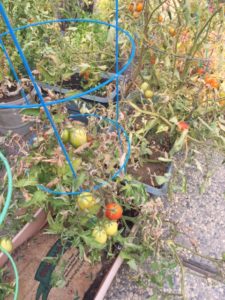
[{"xmin": 0, "ymin": 96, "xmax": 32, "ymax": 136}]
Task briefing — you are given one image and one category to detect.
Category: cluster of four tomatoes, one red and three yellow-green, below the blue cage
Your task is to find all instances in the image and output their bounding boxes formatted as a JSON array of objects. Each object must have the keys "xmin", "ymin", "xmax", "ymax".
[{"xmin": 77, "ymin": 192, "xmax": 123, "ymax": 245}]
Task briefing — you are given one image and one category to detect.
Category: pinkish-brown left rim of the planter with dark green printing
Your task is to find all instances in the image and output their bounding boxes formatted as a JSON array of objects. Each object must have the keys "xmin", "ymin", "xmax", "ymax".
[{"xmin": 0, "ymin": 209, "xmax": 47, "ymax": 268}]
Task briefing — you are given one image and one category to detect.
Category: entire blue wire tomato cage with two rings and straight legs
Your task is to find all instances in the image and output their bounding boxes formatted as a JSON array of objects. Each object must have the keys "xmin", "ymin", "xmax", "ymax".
[{"xmin": 0, "ymin": 0, "xmax": 135, "ymax": 195}]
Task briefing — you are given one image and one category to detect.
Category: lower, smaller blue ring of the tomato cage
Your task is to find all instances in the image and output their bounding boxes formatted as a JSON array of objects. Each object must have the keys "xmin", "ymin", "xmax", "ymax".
[{"xmin": 38, "ymin": 114, "xmax": 131, "ymax": 196}]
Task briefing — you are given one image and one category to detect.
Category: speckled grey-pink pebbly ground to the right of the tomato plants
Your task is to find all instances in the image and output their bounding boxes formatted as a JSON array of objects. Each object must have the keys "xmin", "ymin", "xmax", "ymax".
[{"xmin": 105, "ymin": 146, "xmax": 225, "ymax": 300}]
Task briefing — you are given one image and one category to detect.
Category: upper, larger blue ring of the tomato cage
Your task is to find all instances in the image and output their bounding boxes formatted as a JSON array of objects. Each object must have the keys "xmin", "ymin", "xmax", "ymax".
[{"xmin": 0, "ymin": 19, "xmax": 136, "ymax": 109}]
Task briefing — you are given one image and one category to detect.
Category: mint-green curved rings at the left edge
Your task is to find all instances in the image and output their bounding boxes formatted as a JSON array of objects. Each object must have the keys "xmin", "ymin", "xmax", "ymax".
[{"xmin": 0, "ymin": 152, "xmax": 19, "ymax": 300}]
